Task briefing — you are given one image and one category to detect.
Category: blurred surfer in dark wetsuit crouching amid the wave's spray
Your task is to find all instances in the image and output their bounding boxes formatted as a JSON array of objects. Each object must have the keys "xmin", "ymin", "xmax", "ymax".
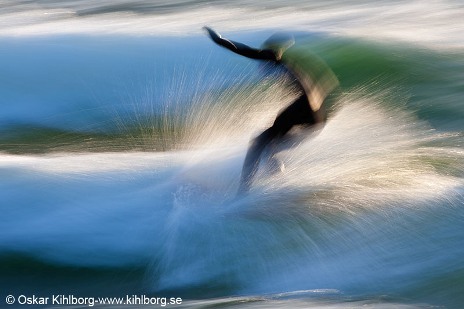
[{"xmin": 204, "ymin": 27, "xmax": 338, "ymax": 192}]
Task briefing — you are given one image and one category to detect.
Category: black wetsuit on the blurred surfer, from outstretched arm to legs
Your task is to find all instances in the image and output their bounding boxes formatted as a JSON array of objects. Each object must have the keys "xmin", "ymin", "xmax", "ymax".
[{"xmin": 205, "ymin": 27, "xmax": 325, "ymax": 192}]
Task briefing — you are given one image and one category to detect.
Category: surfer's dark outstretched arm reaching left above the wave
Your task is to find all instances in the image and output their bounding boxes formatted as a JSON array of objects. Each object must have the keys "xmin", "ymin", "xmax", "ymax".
[{"xmin": 203, "ymin": 27, "xmax": 277, "ymax": 61}]
